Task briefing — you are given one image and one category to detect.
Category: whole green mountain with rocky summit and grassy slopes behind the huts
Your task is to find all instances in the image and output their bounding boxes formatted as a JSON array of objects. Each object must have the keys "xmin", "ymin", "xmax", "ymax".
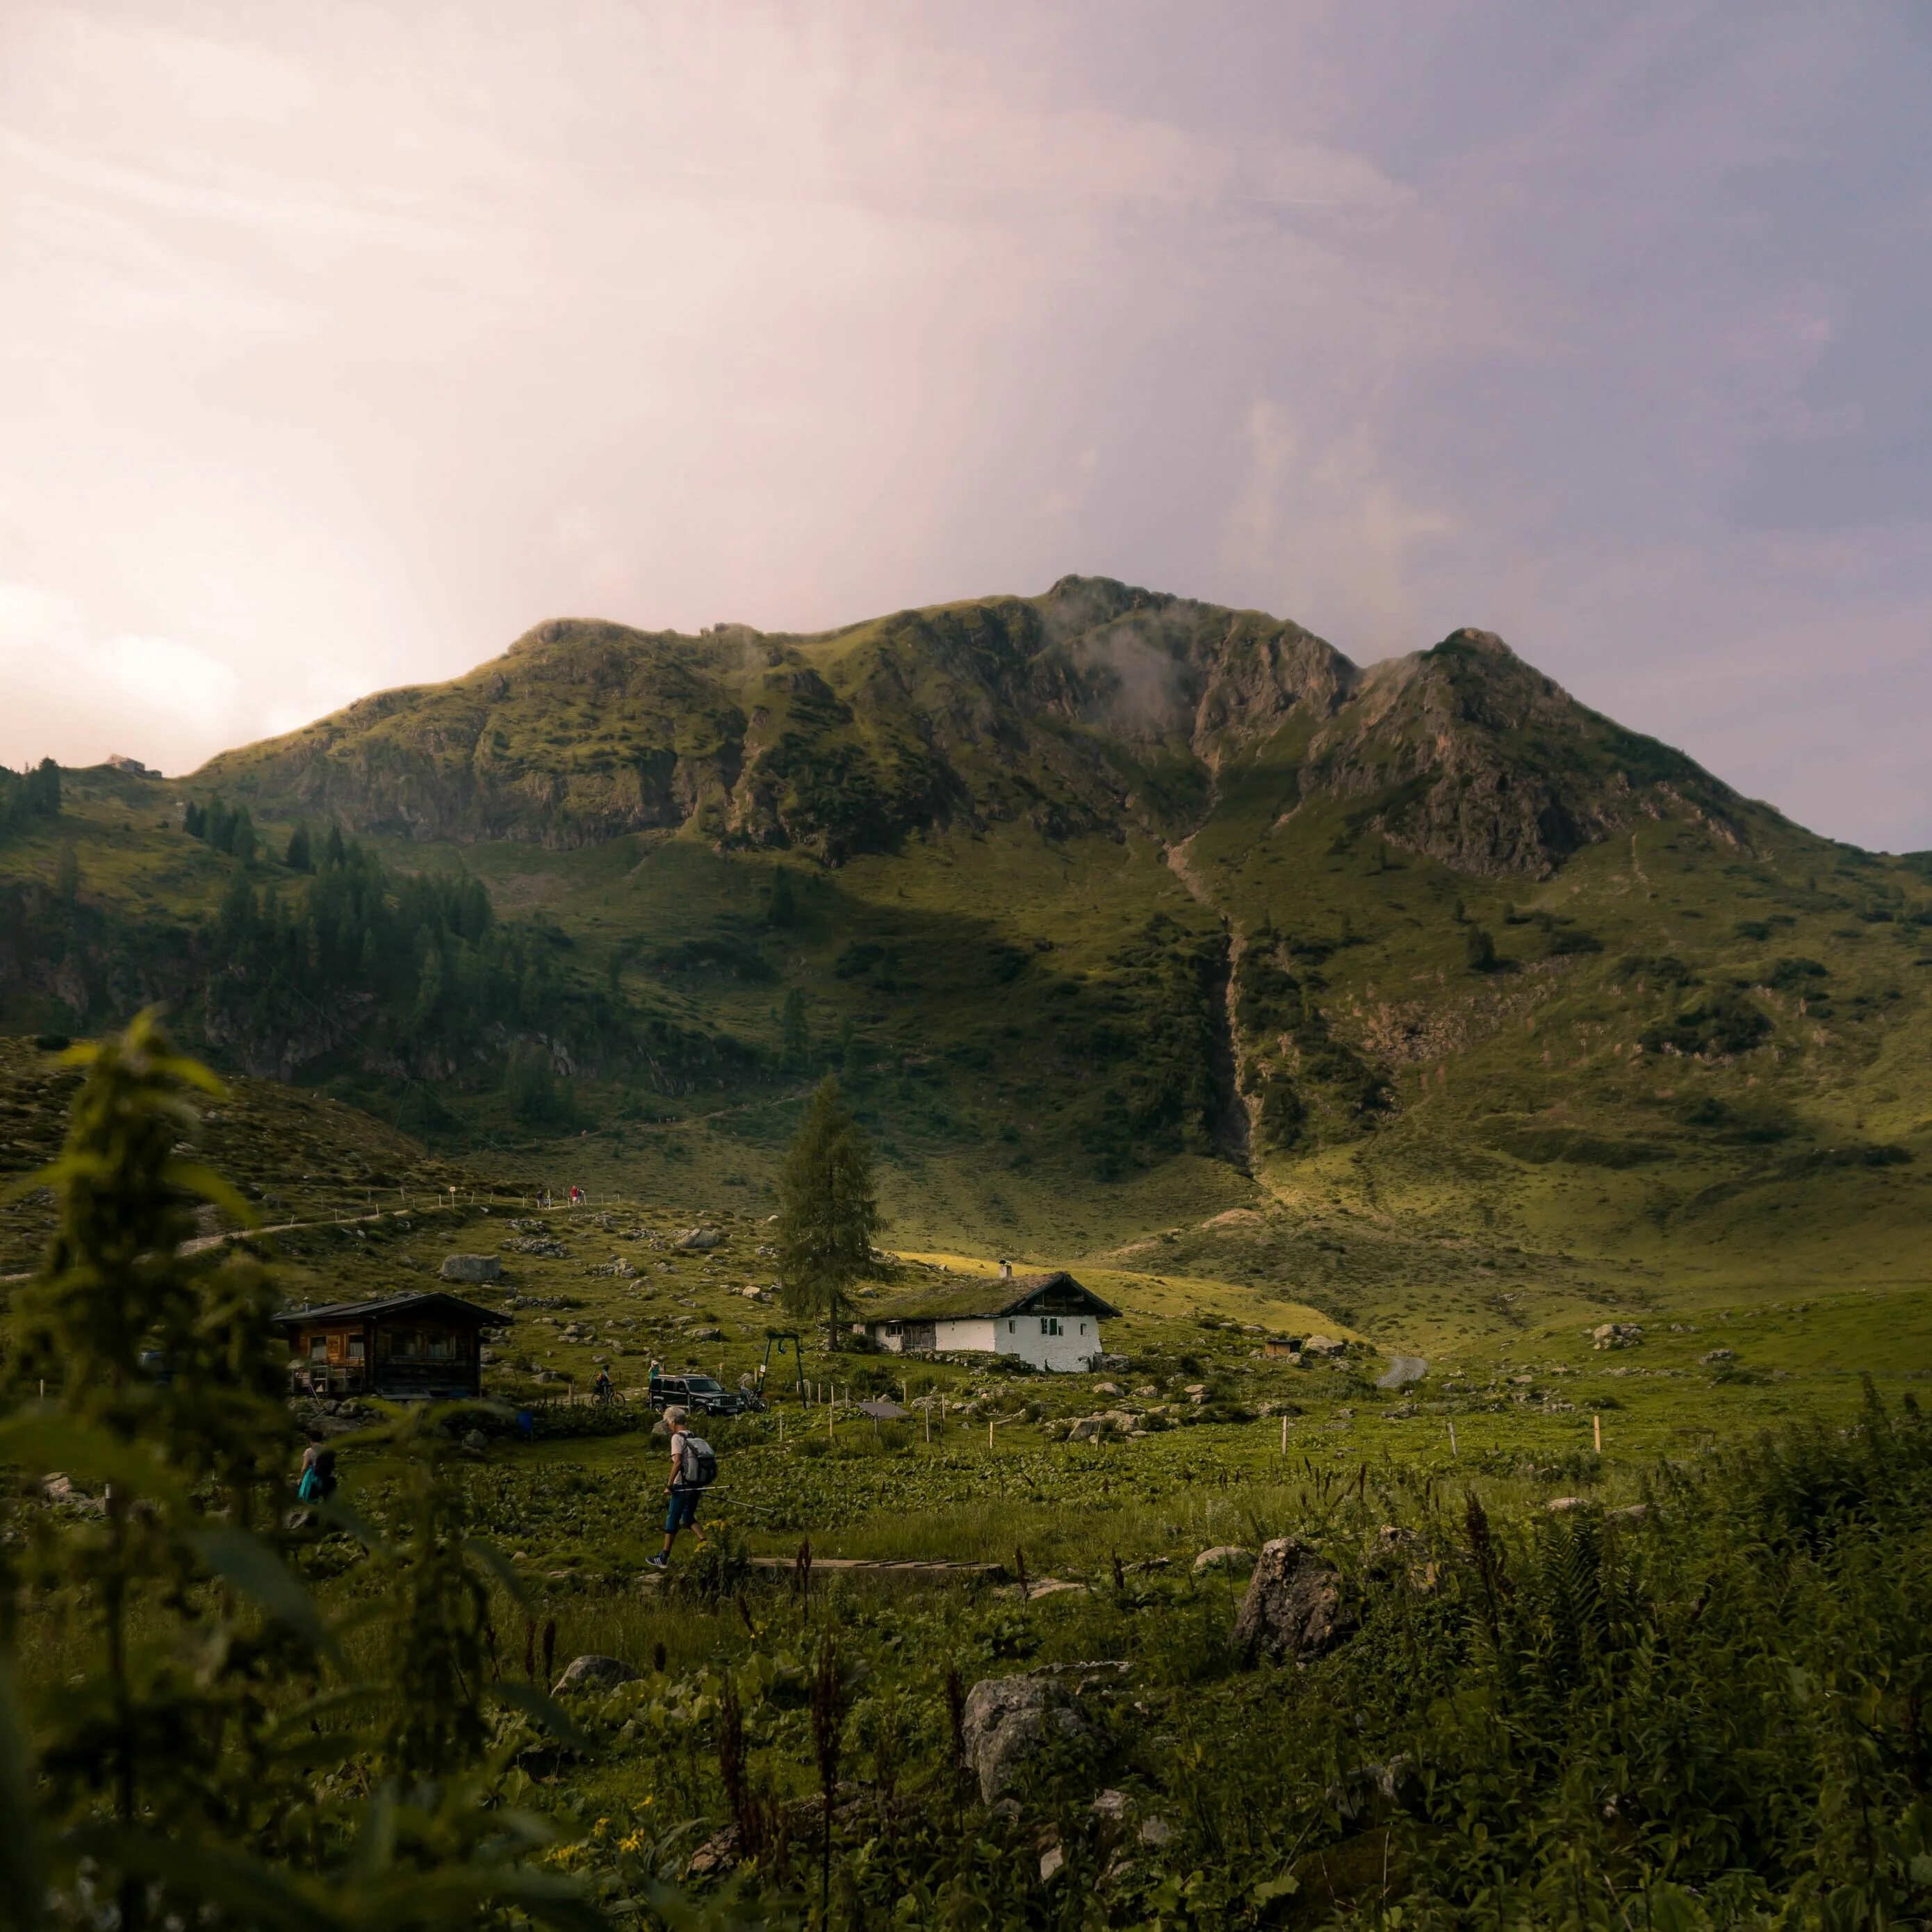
[{"xmin": 0, "ymin": 580, "xmax": 1932, "ymax": 1337}]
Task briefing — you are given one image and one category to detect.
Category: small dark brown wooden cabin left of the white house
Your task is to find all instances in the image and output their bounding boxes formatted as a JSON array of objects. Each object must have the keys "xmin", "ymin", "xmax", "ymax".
[{"xmin": 275, "ymin": 1293, "xmax": 510, "ymax": 1401}]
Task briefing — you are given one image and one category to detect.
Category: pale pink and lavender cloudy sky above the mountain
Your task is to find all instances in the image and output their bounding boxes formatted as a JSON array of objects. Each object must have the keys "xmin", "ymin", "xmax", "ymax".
[{"xmin": 0, "ymin": 0, "xmax": 1932, "ymax": 850}]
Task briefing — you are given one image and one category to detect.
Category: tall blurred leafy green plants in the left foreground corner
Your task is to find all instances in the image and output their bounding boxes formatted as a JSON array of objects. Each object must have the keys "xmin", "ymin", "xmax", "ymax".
[{"xmin": 0, "ymin": 1016, "xmax": 603, "ymax": 1932}]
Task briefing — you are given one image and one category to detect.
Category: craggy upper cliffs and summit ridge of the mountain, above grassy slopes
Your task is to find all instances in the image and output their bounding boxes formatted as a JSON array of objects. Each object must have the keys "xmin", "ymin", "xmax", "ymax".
[{"xmin": 199, "ymin": 578, "xmax": 1735, "ymax": 875}]
